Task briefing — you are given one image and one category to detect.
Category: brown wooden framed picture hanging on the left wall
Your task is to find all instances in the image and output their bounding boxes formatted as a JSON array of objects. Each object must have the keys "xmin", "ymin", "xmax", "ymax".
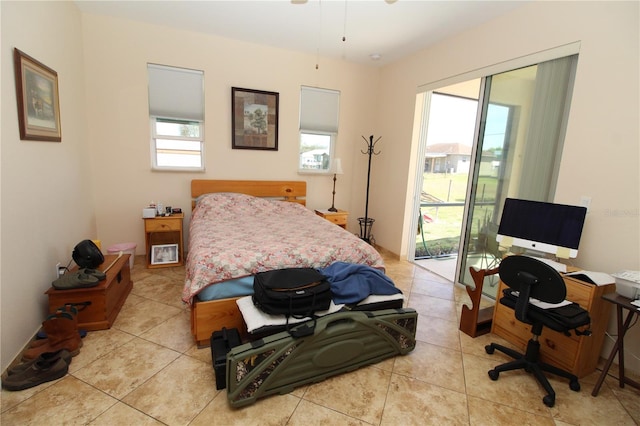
[{"xmin": 13, "ymin": 48, "xmax": 62, "ymax": 142}]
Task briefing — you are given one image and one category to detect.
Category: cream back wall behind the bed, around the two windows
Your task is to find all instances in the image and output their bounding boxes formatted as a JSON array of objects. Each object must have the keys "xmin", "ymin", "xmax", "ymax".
[{"xmin": 83, "ymin": 15, "xmax": 379, "ymax": 254}]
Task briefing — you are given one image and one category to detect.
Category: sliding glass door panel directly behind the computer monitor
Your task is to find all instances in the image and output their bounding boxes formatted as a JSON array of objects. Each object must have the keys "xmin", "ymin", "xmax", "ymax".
[{"xmin": 458, "ymin": 56, "xmax": 576, "ymax": 298}]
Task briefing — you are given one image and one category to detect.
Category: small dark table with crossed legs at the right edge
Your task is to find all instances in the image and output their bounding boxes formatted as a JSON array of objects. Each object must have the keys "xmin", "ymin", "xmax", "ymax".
[{"xmin": 591, "ymin": 293, "xmax": 640, "ymax": 396}]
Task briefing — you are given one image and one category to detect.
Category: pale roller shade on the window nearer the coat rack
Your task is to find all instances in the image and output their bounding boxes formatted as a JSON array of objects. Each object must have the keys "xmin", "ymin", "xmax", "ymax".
[{"xmin": 300, "ymin": 86, "xmax": 340, "ymax": 133}]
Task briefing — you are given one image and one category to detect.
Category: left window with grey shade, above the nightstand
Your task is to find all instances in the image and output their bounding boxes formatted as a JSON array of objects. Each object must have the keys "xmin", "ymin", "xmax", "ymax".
[{"xmin": 147, "ymin": 64, "xmax": 204, "ymax": 171}]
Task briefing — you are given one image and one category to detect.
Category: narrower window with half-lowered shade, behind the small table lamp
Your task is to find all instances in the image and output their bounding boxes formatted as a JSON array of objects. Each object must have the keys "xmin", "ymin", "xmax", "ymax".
[{"xmin": 298, "ymin": 86, "xmax": 340, "ymax": 173}]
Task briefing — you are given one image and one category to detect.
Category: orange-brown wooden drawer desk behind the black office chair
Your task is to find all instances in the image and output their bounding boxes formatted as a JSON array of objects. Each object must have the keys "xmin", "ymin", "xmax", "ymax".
[{"xmin": 491, "ymin": 276, "xmax": 615, "ymax": 378}]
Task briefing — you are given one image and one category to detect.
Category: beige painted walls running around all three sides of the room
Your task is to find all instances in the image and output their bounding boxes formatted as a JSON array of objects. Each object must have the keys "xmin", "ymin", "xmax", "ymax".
[{"xmin": 0, "ymin": 1, "xmax": 640, "ymax": 371}]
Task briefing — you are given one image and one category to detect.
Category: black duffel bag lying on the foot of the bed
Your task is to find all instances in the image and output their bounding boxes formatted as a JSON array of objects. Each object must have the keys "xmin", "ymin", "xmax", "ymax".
[{"xmin": 253, "ymin": 268, "xmax": 331, "ymax": 334}]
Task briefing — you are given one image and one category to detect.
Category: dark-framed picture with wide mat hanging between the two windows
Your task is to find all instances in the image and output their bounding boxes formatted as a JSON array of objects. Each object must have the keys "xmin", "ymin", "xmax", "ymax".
[{"xmin": 231, "ymin": 87, "xmax": 279, "ymax": 151}]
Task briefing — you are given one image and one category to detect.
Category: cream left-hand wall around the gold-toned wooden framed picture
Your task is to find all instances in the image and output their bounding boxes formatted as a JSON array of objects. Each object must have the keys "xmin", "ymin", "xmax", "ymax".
[{"xmin": 0, "ymin": 1, "xmax": 96, "ymax": 370}]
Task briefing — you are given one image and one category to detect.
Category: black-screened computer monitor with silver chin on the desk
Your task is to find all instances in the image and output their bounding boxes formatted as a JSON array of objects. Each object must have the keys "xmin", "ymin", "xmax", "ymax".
[{"xmin": 496, "ymin": 198, "xmax": 587, "ymax": 259}]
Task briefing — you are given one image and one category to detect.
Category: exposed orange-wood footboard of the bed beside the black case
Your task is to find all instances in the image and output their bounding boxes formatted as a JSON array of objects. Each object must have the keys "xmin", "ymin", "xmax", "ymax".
[{"xmin": 191, "ymin": 298, "xmax": 247, "ymax": 348}]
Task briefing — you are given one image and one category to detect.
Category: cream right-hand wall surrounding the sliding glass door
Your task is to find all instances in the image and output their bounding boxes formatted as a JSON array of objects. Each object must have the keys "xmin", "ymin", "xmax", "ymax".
[{"xmin": 371, "ymin": 2, "xmax": 640, "ymax": 371}]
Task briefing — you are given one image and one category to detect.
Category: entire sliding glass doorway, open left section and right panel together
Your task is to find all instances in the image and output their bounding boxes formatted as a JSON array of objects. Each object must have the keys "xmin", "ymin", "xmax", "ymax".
[{"xmin": 414, "ymin": 51, "xmax": 577, "ymax": 297}]
